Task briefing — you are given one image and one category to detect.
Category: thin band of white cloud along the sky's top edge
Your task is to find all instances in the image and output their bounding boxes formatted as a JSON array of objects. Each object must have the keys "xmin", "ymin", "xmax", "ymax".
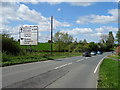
[{"xmin": 2, "ymin": 0, "xmax": 119, "ymax": 6}]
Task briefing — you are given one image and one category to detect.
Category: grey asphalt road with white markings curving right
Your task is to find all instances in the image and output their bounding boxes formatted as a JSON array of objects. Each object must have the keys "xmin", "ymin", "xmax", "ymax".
[{"xmin": 2, "ymin": 52, "xmax": 111, "ymax": 88}]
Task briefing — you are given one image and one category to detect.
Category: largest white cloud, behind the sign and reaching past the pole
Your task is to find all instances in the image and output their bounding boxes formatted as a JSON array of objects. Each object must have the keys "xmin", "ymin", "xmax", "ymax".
[{"xmin": 0, "ymin": 2, "xmax": 70, "ymax": 41}]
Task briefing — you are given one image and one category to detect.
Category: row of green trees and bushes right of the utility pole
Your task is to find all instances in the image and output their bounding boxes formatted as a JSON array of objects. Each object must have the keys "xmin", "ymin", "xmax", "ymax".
[{"xmin": 53, "ymin": 31, "xmax": 120, "ymax": 52}]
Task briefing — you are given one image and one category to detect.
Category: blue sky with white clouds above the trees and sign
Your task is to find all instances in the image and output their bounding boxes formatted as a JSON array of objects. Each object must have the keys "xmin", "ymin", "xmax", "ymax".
[{"xmin": 0, "ymin": 0, "xmax": 118, "ymax": 42}]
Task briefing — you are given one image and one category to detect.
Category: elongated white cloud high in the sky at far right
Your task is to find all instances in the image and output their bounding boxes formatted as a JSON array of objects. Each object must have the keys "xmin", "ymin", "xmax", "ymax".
[{"xmin": 76, "ymin": 9, "xmax": 118, "ymax": 24}]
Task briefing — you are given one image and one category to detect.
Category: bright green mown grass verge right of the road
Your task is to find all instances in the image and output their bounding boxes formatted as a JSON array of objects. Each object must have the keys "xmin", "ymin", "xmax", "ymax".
[{"xmin": 98, "ymin": 55, "xmax": 120, "ymax": 88}]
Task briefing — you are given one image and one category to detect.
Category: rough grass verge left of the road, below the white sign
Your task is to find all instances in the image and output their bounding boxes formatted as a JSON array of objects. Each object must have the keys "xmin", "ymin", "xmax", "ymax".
[{"xmin": 0, "ymin": 52, "xmax": 81, "ymax": 67}]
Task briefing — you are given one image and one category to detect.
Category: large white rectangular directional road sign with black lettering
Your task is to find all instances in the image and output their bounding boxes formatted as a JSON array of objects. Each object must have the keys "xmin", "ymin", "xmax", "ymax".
[{"xmin": 19, "ymin": 26, "xmax": 38, "ymax": 45}]
